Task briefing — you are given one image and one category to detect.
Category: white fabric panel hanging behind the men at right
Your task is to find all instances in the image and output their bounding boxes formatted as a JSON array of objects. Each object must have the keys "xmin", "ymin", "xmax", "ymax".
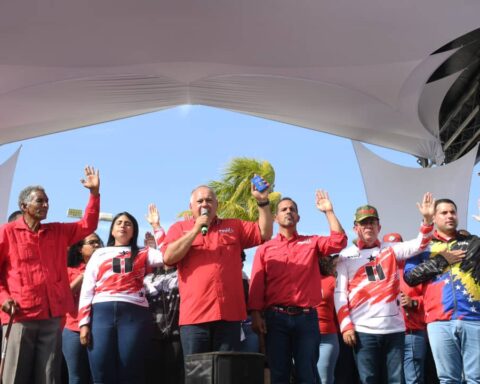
[{"xmin": 353, "ymin": 142, "xmax": 478, "ymax": 240}]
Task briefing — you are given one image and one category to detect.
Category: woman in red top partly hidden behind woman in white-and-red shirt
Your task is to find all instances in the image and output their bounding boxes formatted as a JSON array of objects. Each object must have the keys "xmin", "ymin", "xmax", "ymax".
[{"xmin": 62, "ymin": 233, "xmax": 103, "ymax": 384}]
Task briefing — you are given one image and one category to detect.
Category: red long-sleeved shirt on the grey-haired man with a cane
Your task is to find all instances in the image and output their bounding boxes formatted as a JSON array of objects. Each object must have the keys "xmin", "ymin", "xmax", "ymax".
[{"xmin": 0, "ymin": 195, "xmax": 100, "ymax": 323}]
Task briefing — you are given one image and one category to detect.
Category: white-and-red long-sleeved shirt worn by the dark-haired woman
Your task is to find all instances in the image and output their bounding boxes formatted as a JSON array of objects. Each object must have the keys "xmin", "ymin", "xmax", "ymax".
[{"xmin": 78, "ymin": 230, "xmax": 165, "ymax": 327}]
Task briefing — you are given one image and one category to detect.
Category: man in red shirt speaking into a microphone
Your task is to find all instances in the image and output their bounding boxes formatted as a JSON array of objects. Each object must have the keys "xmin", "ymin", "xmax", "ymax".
[{"xmin": 162, "ymin": 178, "xmax": 273, "ymax": 356}]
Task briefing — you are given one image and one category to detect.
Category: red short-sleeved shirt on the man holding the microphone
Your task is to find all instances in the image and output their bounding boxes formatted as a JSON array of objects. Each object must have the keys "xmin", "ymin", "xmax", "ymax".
[{"xmin": 162, "ymin": 218, "xmax": 262, "ymax": 325}]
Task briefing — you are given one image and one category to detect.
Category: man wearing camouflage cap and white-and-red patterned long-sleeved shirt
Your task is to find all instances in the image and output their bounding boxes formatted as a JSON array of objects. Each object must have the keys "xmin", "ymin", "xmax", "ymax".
[{"xmin": 334, "ymin": 193, "xmax": 434, "ymax": 384}]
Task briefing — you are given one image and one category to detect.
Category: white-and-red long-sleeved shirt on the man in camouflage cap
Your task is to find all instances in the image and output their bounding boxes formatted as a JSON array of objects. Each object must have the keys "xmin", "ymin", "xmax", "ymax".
[{"xmin": 334, "ymin": 225, "xmax": 433, "ymax": 334}]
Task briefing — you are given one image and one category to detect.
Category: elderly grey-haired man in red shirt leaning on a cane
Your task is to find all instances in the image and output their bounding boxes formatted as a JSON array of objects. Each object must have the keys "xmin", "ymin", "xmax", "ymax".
[{"xmin": 0, "ymin": 167, "xmax": 100, "ymax": 384}]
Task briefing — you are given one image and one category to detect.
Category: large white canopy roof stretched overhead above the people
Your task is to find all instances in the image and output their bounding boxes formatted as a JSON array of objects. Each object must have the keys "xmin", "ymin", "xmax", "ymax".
[{"xmin": 0, "ymin": 0, "xmax": 480, "ymax": 162}]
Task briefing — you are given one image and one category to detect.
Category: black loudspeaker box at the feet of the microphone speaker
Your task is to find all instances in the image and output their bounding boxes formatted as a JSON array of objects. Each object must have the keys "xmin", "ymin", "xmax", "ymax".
[{"xmin": 185, "ymin": 352, "xmax": 265, "ymax": 384}]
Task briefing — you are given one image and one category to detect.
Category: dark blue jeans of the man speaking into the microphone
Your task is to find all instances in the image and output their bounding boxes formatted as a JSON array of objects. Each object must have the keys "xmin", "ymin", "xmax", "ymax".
[{"xmin": 180, "ymin": 320, "xmax": 240, "ymax": 356}]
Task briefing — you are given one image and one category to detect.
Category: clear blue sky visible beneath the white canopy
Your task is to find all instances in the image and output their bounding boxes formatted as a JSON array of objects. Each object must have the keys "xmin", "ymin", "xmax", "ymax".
[{"xmin": 0, "ymin": 106, "xmax": 480, "ymax": 269}]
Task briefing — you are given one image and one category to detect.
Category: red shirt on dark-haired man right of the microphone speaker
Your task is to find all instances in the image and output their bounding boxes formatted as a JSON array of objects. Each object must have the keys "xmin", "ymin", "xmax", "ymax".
[{"xmin": 249, "ymin": 231, "xmax": 347, "ymax": 311}]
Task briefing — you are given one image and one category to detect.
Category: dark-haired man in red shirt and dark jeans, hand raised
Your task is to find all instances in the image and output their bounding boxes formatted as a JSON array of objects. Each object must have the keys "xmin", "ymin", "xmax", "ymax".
[{"xmin": 249, "ymin": 191, "xmax": 347, "ymax": 384}]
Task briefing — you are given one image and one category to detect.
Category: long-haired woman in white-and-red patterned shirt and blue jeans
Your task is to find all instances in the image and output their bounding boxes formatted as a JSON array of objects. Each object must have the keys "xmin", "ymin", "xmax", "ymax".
[{"xmin": 79, "ymin": 212, "xmax": 165, "ymax": 384}]
